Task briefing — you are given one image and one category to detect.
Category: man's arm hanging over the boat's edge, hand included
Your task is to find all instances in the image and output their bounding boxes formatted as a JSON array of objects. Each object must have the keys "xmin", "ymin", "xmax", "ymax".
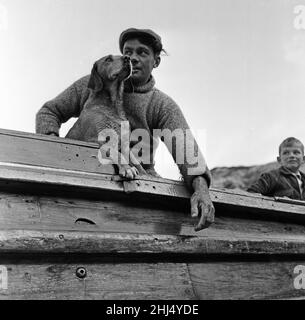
[{"xmin": 155, "ymin": 90, "xmax": 215, "ymax": 231}]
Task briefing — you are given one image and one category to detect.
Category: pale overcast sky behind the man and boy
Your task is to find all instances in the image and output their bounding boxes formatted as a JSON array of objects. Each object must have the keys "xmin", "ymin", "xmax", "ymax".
[{"xmin": 0, "ymin": 0, "xmax": 305, "ymax": 178}]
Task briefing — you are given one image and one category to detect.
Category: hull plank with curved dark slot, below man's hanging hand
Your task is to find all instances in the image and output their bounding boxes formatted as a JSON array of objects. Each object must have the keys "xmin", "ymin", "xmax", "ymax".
[{"xmin": 0, "ymin": 193, "xmax": 190, "ymax": 234}]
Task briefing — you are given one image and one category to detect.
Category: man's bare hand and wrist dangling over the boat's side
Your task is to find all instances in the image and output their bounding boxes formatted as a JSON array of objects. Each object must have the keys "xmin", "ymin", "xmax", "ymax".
[{"xmin": 191, "ymin": 176, "xmax": 215, "ymax": 231}]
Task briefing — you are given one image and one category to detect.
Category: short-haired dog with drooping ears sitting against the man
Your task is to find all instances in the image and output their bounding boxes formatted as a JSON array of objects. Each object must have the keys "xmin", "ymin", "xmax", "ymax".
[{"xmin": 66, "ymin": 55, "xmax": 145, "ymax": 179}]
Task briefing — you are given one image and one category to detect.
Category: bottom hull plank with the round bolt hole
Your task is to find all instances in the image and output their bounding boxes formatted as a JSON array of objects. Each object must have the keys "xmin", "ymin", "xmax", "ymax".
[{"xmin": 0, "ymin": 259, "xmax": 194, "ymax": 300}]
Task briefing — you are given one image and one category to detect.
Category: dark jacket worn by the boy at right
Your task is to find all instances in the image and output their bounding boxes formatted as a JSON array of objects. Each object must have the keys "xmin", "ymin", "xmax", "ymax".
[{"xmin": 247, "ymin": 167, "xmax": 305, "ymax": 200}]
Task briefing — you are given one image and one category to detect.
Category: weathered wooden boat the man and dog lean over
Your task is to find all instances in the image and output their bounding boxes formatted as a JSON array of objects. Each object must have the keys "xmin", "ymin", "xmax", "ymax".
[{"xmin": 0, "ymin": 130, "xmax": 305, "ymax": 300}]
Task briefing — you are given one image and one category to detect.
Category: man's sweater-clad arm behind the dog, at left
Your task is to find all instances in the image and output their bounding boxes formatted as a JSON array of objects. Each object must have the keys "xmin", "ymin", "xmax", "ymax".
[{"xmin": 36, "ymin": 77, "xmax": 89, "ymax": 136}]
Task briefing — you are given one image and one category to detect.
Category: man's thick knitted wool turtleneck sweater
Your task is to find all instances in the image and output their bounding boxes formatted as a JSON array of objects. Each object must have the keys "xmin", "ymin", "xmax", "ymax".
[{"xmin": 36, "ymin": 75, "xmax": 211, "ymax": 188}]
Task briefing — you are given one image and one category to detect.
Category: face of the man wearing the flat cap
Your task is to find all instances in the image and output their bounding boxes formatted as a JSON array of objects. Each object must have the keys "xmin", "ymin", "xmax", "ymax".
[{"xmin": 123, "ymin": 39, "xmax": 160, "ymax": 85}]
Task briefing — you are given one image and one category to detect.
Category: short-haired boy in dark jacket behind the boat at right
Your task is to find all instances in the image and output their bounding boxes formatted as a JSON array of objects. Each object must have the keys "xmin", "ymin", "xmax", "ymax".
[{"xmin": 247, "ymin": 137, "xmax": 305, "ymax": 200}]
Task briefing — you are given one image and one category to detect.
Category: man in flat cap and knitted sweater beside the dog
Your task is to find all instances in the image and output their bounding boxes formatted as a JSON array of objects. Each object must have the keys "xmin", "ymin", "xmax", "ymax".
[{"xmin": 36, "ymin": 28, "xmax": 215, "ymax": 231}]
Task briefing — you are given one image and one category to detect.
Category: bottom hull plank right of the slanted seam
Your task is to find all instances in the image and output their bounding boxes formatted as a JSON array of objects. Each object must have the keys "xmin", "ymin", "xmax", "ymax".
[{"xmin": 188, "ymin": 260, "xmax": 305, "ymax": 300}]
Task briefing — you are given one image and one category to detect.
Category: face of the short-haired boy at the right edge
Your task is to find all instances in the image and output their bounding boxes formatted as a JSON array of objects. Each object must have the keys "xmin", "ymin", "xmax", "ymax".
[{"xmin": 277, "ymin": 143, "xmax": 305, "ymax": 172}]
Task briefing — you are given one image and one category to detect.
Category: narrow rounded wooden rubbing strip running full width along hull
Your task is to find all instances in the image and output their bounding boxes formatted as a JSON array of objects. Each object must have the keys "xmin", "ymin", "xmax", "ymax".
[{"xmin": 0, "ymin": 230, "xmax": 305, "ymax": 257}]
